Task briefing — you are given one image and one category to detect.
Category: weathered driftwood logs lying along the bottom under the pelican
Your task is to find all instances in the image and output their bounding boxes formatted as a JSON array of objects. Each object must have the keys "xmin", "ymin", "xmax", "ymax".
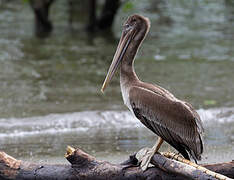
[{"xmin": 0, "ymin": 147, "xmax": 234, "ymax": 180}]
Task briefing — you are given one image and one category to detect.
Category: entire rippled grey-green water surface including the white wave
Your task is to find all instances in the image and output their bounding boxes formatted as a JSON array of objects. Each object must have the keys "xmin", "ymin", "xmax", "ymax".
[{"xmin": 0, "ymin": 0, "xmax": 234, "ymax": 162}]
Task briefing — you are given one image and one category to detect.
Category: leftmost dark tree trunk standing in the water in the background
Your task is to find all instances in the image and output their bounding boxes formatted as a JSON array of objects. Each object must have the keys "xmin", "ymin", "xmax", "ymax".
[{"xmin": 29, "ymin": 0, "xmax": 54, "ymax": 37}]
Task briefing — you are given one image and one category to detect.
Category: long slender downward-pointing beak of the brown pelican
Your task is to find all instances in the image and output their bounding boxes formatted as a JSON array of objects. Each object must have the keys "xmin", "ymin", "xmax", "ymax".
[{"xmin": 101, "ymin": 30, "xmax": 134, "ymax": 93}]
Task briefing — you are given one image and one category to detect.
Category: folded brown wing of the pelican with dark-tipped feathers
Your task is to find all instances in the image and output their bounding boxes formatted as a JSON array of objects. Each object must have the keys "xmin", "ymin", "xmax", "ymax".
[{"xmin": 129, "ymin": 86, "xmax": 203, "ymax": 160}]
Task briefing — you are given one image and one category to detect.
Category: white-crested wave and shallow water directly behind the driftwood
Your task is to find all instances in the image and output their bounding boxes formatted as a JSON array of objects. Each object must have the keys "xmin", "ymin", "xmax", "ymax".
[{"xmin": 0, "ymin": 108, "xmax": 234, "ymax": 162}]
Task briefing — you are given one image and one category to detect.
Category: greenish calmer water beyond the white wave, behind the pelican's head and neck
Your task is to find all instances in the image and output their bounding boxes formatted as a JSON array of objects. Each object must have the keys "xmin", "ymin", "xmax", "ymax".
[{"xmin": 0, "ymin": 1, "xmax": 234, "ymax": 117}]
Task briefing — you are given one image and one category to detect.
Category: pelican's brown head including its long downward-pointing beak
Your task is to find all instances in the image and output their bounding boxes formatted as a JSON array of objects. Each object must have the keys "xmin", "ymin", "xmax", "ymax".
[{"xmin": 101, "ymin": 14, "xmax": 150, "ymax": 92}]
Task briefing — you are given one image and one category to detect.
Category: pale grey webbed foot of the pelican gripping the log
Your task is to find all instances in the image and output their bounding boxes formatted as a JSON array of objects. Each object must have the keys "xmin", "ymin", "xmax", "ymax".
[{"xmin": 136, "ymin": 147, "xmax": 155, "ymax": 171}]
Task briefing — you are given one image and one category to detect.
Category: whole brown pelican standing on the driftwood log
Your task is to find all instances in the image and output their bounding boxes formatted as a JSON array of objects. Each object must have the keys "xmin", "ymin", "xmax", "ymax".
[{"xmin": 102, "ymin": 15, "xmax": 204, "ymax": 170}]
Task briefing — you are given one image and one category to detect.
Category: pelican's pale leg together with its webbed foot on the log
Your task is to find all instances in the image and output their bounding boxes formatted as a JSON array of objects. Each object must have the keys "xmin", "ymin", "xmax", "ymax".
[{"xmin": 136, "ymin": 137, "xmax": 163, "ymax": 171}]
